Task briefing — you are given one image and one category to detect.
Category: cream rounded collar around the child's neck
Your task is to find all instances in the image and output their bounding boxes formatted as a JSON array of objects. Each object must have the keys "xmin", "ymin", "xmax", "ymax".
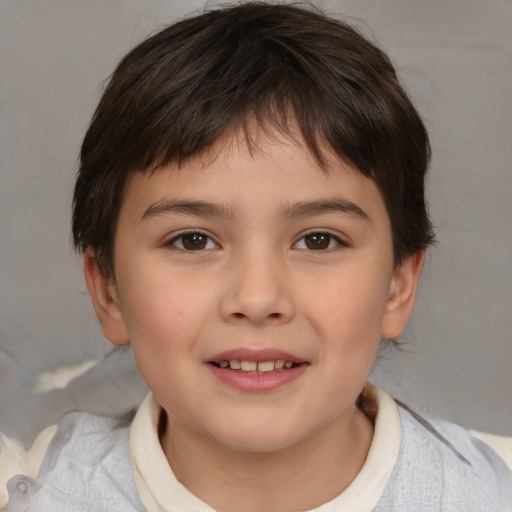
[{"xmin": 130, "ymin": 383, "xmax": 401, "ymax": 512}]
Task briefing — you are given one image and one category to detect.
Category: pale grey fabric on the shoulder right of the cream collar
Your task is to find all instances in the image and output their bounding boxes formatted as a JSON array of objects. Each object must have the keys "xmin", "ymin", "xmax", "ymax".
[{"xmin": 376, "ymin": 406, "xmax": 512, "ymax": 512}]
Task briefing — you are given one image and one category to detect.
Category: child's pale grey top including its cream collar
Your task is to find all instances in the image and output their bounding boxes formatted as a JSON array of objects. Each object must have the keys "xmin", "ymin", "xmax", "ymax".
[{"xmin": 5, "ymin": 386, "xmax": 512, "ymax": 512}]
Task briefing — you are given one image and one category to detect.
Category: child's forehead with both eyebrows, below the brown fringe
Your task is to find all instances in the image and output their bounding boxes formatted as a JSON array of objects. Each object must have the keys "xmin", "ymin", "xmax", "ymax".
[{"xmin": 120, "ymin": 137, "xmax": 389, "ymax": 239}]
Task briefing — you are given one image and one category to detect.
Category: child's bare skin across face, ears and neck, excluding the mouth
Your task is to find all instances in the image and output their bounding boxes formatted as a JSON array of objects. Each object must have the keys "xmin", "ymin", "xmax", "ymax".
[{"xmin": 85, "ymin": 133, "xmax": 423, "ymax": 512}]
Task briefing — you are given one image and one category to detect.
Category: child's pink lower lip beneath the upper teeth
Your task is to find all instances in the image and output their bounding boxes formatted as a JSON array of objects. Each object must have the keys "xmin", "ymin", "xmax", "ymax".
[{"xmin": 207, "ymin": 363, "xmax": 309, "ymax": 393}]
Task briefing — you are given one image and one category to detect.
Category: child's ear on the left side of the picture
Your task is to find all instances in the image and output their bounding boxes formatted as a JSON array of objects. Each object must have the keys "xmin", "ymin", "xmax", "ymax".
[{"xmin": 84, "ymin": 249, "xmax": 129, "ymax": 345}]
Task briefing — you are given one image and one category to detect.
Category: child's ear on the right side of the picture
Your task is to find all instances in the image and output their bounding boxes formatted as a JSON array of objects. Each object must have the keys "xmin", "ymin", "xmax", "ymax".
[{"xmin": 381, "ymin": 251, "xmax": 425, "ymax": 339}]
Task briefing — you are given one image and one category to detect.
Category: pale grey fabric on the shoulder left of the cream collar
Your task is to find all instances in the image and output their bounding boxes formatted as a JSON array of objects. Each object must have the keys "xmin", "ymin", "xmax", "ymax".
[{"xmin": 5, "ymin": 412, "xmax": 144, "ymax": 512}]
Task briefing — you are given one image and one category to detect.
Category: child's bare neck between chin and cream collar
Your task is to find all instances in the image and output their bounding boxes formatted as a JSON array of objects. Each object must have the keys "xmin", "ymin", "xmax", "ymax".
[{"xmin": 161, "ymin": 407, "xmax": 373, "ymax": 512}]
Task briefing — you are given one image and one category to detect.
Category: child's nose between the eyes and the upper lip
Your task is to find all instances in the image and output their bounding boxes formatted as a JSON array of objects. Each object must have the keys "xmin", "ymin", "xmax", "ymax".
[{"xmin": 220, "ymin": 254, "xmax": 295, "ymax": 325}]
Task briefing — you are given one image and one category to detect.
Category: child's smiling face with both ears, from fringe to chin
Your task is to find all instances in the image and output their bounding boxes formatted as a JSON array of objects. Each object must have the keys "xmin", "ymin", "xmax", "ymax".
[{"xmin": 86, "ymin": 131, "xmax": 421, "ymax": 451}]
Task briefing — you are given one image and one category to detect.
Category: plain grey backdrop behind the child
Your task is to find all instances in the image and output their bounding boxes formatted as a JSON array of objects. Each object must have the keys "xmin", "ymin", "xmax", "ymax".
[{"xmin": 0, "ymin": 0, "xmax": 512, "ymax": 436}]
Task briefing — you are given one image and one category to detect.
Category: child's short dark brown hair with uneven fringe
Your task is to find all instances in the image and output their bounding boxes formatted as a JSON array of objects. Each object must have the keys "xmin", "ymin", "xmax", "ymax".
[{"xmin": 72, "ymin": 2, "xmax": 433, "ymax": 276}]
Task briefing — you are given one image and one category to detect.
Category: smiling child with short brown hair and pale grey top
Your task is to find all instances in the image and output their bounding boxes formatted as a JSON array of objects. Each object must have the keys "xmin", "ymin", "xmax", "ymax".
[{"xmin": 2, "ymin": 3, "xmax": 512, "ymax": 512}]
